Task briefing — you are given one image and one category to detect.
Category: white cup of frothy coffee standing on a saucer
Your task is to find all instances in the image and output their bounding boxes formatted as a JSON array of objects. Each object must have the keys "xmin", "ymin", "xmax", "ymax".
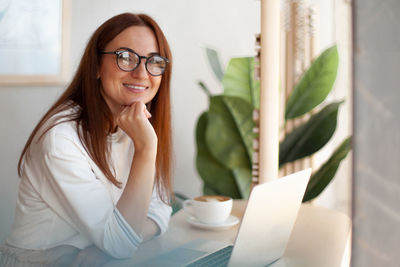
[{"xmin": 183, "ymin": 195, "xmax": 232, "ymax": 224}]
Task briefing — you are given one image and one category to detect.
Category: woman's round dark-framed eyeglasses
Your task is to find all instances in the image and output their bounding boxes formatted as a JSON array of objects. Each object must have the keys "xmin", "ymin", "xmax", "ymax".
[{"xmin": 100, "ymin": 48, "xmax": 169, "ymax": 76}]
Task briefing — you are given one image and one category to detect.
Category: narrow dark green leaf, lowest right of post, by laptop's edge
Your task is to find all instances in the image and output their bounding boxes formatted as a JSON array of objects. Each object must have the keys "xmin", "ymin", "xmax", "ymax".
[{"xmin": 303, "ymin": 137, "xmax": 351, "ymax": 202}]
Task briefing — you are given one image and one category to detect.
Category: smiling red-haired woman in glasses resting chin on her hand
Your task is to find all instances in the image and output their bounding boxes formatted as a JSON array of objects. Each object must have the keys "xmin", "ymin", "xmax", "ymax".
[{"xmin": 0, "ymin": 13, "xmax": 172, "ymax": 266}]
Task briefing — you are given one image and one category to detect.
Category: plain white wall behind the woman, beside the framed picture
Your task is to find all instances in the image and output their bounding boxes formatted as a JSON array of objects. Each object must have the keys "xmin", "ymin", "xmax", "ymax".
[{"xmin": 0, "ymin": 0, "xmax": 346, "ymax": 242}]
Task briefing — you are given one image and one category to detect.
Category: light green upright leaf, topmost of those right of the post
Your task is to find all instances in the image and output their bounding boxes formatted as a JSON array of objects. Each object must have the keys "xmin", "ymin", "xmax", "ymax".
[{"xmin": 285, "ymin": 45, "xmax": 339, "ymax": 119}]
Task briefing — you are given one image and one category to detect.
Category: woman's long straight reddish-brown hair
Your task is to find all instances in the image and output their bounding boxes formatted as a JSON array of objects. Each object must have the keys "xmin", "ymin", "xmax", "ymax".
[{"xmin": 18, "ymin": 13, "xmax": 172, "ymax": 202}]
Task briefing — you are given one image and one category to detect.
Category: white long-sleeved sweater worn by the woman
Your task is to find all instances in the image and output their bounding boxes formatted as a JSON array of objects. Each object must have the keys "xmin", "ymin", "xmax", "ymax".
[{"xmin": 6, "ymin": 109, "xmax": 171, "ymax": 258}]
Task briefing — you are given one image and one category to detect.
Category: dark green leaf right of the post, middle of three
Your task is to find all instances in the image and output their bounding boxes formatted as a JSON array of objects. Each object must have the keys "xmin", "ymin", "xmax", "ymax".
[{"xmin": 279, "ymin": 102, "xmax": 342, "ymax": 166}]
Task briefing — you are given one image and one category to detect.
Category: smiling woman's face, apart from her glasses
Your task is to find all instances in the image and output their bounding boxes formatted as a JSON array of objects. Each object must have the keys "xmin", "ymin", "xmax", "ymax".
[{"xmin": 99, "ymin": 26, "xmax": 162, "ymax": 116}]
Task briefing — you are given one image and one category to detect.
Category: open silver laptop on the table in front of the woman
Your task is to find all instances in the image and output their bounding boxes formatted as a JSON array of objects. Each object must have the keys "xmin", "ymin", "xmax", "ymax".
[{"xmin": 139, "ymin": 169, "xmax": 311, "ymax": 267}]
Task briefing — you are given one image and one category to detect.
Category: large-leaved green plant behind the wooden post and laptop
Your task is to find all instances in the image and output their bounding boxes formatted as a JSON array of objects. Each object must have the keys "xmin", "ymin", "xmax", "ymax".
[{"xmin": 196, "ymin": 46, "xmax": 351, "ymax": 201}]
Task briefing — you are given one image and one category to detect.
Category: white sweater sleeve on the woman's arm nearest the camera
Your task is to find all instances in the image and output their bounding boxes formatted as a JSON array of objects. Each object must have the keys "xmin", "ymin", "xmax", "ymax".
[{"xmin": 40, "ymin": 135, "xmax": 143, "ymax": 258}]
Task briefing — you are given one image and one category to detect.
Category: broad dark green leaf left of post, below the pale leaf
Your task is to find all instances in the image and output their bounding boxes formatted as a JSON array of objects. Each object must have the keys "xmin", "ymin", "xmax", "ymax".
[{"xmin": 206, "ymin": 95, "xmax": 254, "ymax": 169}]
